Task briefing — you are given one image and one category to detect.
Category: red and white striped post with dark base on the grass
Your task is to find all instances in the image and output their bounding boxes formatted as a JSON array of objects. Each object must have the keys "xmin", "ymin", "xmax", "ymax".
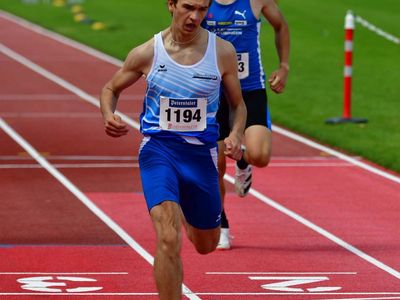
[{"xmin": 326, "ymin": 10, "xmax": 367, "ymax": 124}]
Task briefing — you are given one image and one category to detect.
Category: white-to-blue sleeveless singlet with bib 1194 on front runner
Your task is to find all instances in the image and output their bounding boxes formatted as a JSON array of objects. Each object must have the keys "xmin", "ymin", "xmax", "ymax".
[{"xmin": 140, "ymin": 32, "xmax": 221, "ymax": 144}]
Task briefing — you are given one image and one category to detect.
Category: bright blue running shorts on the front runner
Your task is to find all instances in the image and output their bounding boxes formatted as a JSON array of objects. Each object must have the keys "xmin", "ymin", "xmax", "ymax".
[{"xmin": 139, "ymin": 136, "xmax": 222, "ymax": 229}]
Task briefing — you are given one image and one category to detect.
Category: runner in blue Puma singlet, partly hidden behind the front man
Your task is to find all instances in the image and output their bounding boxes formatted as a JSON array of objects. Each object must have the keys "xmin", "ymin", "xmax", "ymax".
[{"xmin": 202, "ymin": 0, "xmax": 289, "ymax": 249}]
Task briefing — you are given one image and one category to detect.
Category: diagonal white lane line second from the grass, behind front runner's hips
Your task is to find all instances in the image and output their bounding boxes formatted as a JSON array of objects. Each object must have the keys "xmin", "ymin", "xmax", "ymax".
[{"xmin": 0, "ymin": 40, "xmax": 400, "ymax": 279}]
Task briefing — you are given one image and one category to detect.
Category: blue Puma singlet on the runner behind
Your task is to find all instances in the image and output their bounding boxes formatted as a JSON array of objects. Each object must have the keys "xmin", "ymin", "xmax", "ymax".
[{"xmin": 202, "ymin": 0, "xmax": 265, "ymax": 91}]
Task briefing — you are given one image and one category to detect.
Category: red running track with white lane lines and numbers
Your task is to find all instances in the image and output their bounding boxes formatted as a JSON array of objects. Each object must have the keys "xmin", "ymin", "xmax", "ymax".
[{"xmin": 0, "ymin": 12, "xmax": 400, "ymax": 299}]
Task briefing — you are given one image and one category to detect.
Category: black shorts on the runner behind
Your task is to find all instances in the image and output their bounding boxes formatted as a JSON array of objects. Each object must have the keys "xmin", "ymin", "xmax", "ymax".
[{"xmin": 217, "ymin": 89, "xmax": 271, "ymax": 141}]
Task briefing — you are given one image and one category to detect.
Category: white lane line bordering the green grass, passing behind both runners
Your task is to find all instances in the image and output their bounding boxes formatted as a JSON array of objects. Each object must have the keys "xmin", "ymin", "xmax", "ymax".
[{"xmin": 0, "ymin": 12, "xmax": 400, "ymax": 183}]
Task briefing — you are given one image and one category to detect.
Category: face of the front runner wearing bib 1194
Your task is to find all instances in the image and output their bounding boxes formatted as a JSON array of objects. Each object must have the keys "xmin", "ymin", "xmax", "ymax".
[{"xmin": 168, "ymin": 0, "xmax": 210, "ymax": 33}]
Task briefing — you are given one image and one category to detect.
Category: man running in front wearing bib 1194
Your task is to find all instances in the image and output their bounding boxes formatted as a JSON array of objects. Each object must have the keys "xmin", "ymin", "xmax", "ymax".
[{"xmin": 100, "ymin": 0, "xmax": 247, "ymax": 299}]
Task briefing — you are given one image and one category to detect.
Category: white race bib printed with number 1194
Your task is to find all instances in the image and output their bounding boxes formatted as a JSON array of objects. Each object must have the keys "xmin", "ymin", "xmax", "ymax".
[{"xmin": 160, "ymin": 97, "xmax": 207, "ymax": 131}]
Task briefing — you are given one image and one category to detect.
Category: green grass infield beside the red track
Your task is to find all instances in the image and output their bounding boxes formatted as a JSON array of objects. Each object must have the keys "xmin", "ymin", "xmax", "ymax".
[{"xmin": 0, "ymin": 0, "xmax": 400, "ymax": 172}]
